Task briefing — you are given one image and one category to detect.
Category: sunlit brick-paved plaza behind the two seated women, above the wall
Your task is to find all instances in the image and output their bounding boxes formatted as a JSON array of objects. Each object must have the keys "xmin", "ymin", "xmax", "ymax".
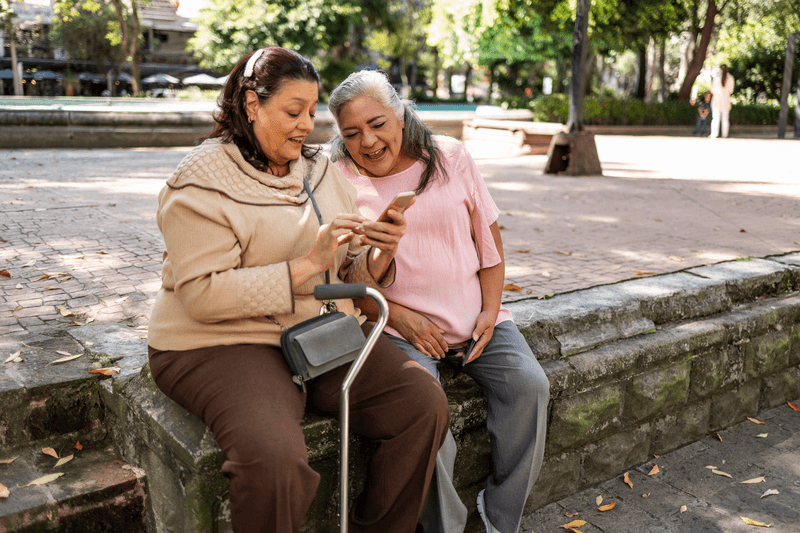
[{"xmin": 0, "ymin": 136, "xmax": 800, "ymax": 351}]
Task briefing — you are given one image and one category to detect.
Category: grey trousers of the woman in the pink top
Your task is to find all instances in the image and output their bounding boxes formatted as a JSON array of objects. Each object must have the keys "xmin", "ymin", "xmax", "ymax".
[{"xmin": 389, "ymin": 320, "xmax": 550, "ymax": 533}]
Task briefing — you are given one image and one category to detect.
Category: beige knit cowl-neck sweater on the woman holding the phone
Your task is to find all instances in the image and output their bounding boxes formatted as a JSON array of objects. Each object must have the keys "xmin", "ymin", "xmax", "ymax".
[{"xmin": 147, "ymin": 139, "xmax": 394, "ymax": 350}]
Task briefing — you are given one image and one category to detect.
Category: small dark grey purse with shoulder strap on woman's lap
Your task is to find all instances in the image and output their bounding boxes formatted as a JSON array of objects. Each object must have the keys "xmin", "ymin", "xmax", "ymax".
[{"xmin": 268, "ymin": 178, "xmax": 367, "ymax": 392}]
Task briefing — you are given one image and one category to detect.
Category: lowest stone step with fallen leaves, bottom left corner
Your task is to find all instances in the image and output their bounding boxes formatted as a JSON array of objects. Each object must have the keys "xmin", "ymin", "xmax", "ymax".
[{"xmin": 0, "ymin": 440, "xmax": 145, "ymax": 533}]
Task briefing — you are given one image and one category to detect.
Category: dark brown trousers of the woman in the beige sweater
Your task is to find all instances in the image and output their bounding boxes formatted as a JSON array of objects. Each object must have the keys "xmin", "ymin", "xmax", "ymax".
[{"xmin": 150, "ymin": 326, "xmax": 450, "ymax": 533}]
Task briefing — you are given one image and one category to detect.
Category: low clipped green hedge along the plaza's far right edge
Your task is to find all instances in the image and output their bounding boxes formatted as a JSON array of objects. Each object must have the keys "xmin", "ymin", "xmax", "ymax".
[{"xmin": 502, "ymin": 94, "xmax": 794, "ymax": 126}]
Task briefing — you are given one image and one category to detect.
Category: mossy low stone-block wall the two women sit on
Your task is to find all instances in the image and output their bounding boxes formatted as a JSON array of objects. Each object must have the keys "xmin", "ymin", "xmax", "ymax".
[{"xmin": 101, "ymin": 254, "xmax": 800, "ymax": 533}]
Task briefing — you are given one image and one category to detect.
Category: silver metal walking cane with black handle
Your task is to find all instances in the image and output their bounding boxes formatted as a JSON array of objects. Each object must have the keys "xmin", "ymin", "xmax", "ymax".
[{"xmin": 314, "ymin": 283, "xmax": 389, "ymax": 533}]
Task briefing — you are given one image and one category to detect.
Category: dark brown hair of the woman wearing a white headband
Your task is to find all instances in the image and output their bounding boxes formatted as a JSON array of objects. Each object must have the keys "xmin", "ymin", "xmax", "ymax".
[{"xmin": 199, "ymin": 46, "xmax": 320, "ymax": 172}]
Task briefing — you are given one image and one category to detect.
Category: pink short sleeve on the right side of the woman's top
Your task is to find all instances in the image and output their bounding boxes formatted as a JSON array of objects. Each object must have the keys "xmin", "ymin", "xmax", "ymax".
[{"xmin": 457, "ymin": 146, "xmax": 501, "ymax": 269}]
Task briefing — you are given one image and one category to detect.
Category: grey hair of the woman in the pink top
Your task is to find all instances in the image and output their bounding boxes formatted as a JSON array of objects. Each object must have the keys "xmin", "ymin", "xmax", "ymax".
[{"xmin": 328, "ymin": 70, "xmax": 448, "ymax": 194}]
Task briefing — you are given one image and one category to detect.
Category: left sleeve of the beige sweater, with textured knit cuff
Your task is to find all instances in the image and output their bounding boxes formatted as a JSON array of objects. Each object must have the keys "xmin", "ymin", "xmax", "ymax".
[{"xmin": 159, "ymin": 187, "xmax": 294, "ymax": 323}]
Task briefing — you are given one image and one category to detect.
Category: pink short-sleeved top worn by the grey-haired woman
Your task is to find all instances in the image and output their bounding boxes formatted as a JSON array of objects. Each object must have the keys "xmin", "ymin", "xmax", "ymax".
[{"xmin": 335, "ymin": 136, "xmax": 511, "ymax": 344}]
